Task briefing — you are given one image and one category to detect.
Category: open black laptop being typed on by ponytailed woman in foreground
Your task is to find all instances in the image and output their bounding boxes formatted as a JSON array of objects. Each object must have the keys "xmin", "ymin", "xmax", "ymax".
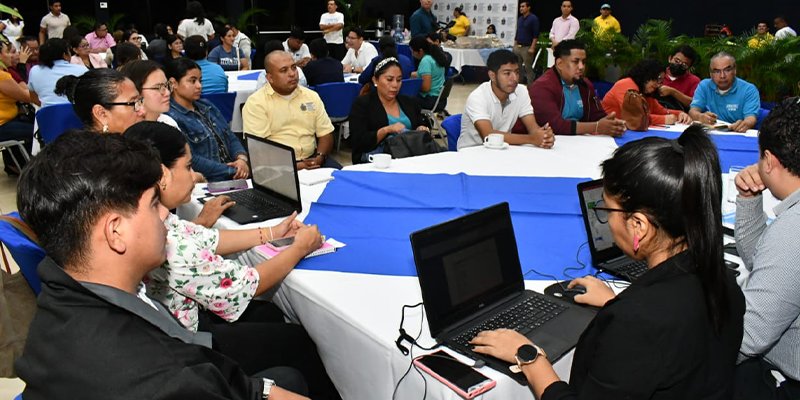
[{"xmin": 411, "ymin": 203, "xmax": 595, "ymax": 385}]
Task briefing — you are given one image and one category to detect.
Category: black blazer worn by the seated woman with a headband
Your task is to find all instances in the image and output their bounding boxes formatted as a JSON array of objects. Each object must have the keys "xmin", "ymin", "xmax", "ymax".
[{"xmin": 349, "ymin": 90, "xmax": 425, "ymax": 164}]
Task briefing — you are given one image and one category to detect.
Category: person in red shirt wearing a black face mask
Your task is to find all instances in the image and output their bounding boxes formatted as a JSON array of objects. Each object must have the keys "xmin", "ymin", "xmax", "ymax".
[{"xmin": 658, "ymin": 45, "xmax": 700, "ymax": 111}]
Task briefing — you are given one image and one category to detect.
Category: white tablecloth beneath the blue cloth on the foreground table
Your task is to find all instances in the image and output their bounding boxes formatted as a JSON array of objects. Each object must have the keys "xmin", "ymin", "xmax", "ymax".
[{"xmin": 179, "ymin": 136, "xmax": 617, "ymax": 400}]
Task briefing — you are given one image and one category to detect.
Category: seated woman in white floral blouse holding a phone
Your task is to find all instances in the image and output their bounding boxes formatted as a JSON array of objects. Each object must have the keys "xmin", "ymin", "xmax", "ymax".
[{"xmin": 125, "ymin": 121, "xmax": 339, "ymax": 399}]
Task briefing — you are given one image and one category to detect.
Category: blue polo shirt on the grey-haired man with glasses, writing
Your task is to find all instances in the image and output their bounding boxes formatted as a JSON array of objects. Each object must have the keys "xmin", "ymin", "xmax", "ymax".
[{"xmin": 691, "ymin": 78, "xmax": 761, "ymax": 123}]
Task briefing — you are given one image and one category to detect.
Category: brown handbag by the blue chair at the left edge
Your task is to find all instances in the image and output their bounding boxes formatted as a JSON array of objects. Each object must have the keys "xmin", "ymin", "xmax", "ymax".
[{"xmin": 0, "ymin": 216, "xmax": 36, "ymax": 378}]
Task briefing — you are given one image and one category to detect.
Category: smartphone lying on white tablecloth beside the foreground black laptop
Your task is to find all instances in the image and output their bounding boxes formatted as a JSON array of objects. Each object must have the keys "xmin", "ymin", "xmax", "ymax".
[{"xmin": 414, "ymin": 350, "xmax": 497, "ymax": 399}]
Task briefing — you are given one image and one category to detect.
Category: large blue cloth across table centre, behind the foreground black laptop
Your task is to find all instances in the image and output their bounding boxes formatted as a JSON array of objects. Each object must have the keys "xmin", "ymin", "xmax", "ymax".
[{"xmin": 298, "ymin": 171, "xmax": 590, "ymax": 278}]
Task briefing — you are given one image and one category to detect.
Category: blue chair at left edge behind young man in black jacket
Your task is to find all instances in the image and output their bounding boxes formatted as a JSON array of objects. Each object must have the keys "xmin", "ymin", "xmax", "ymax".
[{"xmin": 0, "ymin": 212, "xmax": 45, "ymax": 296}]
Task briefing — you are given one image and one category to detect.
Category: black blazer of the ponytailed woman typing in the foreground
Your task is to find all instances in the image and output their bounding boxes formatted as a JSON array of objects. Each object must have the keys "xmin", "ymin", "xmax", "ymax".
[{"xmin": 542, "ymin": 252, "xmax": 745, "ymax": 400}]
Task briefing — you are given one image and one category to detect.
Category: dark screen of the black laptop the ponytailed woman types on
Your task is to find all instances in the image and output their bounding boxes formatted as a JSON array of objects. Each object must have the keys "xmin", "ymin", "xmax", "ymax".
[{"xmin": 411, "ymin": 203, "xmax": 524, "ymax": 337}]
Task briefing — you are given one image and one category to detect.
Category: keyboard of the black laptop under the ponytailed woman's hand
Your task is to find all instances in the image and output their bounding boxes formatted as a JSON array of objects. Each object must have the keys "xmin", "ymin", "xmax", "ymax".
[{"xmin": 453, "ymin": 296, "xmax": 567, "ymax": 347}]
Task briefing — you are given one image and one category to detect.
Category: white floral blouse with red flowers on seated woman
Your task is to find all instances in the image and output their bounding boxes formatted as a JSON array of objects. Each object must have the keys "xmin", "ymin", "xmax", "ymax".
[{"xmin": 145, "ymin": 214, "xmax": 259, "ymax": 332}]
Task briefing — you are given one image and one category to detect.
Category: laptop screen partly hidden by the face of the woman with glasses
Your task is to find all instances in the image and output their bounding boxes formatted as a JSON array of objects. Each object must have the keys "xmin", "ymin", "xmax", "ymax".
[{"xmin": 578, "ymin": 179, "xmax": 622, "ymax": 264}]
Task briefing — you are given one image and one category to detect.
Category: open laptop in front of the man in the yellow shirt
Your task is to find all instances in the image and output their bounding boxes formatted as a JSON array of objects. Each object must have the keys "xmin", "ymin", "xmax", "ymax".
[{"xmin": 208, "ymin": 134, "xmax": 303, "ymax": 224}]
